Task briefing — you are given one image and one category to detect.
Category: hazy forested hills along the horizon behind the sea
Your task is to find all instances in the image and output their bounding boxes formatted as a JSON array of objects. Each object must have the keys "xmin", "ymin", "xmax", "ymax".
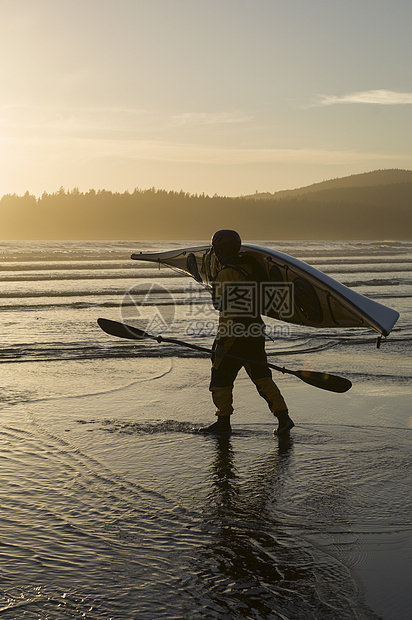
[{"xmin": 0, "ymin": 170, "xmax": 412, "ymax": 240}]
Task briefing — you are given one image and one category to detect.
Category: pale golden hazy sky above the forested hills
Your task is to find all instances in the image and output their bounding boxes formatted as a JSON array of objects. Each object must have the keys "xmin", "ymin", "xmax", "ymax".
[{"xmin": 0, "ymin": 0, "xmax": 412, "ymax": 196}]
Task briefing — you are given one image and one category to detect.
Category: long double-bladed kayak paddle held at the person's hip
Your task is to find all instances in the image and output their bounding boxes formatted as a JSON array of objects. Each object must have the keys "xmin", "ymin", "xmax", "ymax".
[{"xmin": 97, "ymin": 319, "xmax": 352, "ymax": 393}]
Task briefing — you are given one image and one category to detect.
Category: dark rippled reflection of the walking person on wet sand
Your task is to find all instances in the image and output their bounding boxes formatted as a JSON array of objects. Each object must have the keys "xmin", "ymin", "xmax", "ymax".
[{"xmin": 190, "ymin": 437, "xmax": 366, "ymax": 620}]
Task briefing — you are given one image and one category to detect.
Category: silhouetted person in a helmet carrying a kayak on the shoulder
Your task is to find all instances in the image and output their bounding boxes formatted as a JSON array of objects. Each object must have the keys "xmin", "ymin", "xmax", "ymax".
[{"xmin": 201, "ymin": 230, "xmax": 294, "ymax": 435}]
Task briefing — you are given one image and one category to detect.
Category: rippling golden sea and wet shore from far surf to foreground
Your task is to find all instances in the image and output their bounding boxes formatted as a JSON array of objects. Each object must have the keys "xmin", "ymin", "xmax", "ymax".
[{"xmin": 0, "ymin": 240, "xmax": 412, "ymax": 620}]
